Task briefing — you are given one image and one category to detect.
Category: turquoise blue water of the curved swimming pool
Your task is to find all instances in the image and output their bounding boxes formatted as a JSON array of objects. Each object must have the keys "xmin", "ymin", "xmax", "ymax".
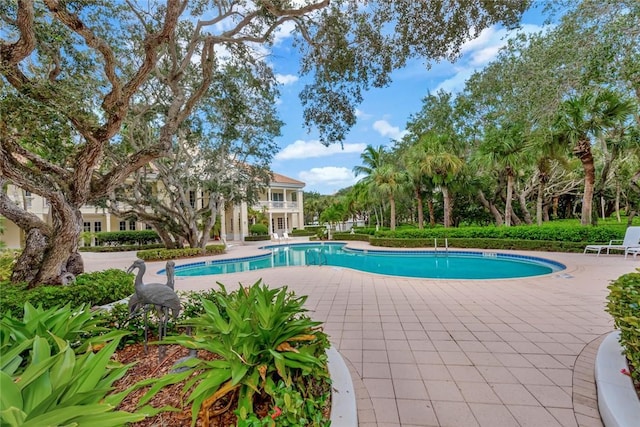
[{"xmin": 171, "ymin": 243, "xmax": 565, "ymax": 279}]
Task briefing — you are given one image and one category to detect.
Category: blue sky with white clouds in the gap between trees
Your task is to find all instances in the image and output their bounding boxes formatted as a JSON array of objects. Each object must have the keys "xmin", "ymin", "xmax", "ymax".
[{"xmin": 264, "ymin": 4, "xmax": 556, "ymax": 195}]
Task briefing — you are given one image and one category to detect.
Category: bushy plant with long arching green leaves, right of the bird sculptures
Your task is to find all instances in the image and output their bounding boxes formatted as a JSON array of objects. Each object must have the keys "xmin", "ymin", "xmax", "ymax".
[{"xmin": 151, "ymin": 281, "xmax": 329, "ymax": 425}]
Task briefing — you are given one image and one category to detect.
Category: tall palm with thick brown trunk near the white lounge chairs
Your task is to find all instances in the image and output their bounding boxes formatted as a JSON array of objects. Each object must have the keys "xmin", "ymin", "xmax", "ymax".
[{"xmin": 554, "ymin": 90, "xmax": 633, "ymax": 225}]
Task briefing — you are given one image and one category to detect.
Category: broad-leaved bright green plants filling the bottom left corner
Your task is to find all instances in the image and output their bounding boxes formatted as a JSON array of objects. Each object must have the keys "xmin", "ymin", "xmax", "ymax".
[{"xmin": 0, "ymin": 305, "xmax": 164, "ymax": 427}]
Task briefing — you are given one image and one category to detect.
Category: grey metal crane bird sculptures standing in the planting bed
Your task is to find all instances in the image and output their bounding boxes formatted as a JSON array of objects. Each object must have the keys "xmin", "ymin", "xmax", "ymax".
[{"xmin": 127, "ymin": 259, "xmax": 181, "ymax": 351}]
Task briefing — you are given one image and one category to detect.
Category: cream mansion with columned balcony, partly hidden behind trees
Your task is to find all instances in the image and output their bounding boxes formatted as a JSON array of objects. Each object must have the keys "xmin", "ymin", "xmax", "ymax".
[{"xmin": 0, "ymin": 173, "xmax": 305, "ymax": 248}]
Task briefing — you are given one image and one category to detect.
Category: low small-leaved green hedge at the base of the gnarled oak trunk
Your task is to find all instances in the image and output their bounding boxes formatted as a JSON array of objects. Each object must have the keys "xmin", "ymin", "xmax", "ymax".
[{"xmin": 0, "ymin": 269, "xmax": 134, "ymax": 317}]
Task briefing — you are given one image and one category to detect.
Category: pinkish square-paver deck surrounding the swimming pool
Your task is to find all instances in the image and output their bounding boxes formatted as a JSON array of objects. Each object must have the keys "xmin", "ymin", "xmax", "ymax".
[{"xmin": 83, "ymin": 239, "xmax": 640, "ymax": 427}]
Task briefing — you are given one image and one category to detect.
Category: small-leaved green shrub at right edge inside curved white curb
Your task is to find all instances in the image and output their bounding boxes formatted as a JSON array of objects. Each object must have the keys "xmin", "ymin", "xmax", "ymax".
[{"xmin": 606, "ymin": 270, "xmax": 640, "ymax": 383}]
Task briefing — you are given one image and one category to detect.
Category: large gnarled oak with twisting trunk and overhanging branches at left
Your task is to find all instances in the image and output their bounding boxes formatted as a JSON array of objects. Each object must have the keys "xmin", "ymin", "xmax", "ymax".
[{"xmin": 0, "ymin": 0, "xmax": 529, "ymax": 286}]
